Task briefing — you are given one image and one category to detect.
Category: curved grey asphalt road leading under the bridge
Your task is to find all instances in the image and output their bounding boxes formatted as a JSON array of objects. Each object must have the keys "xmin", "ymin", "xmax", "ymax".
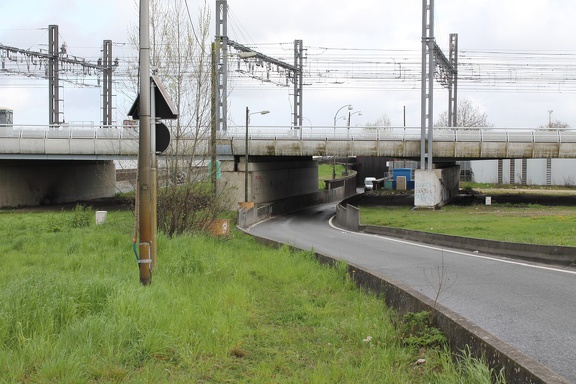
[{"xmin": 248, "ymin": 204, "xmax": 576, "ymax": 383}]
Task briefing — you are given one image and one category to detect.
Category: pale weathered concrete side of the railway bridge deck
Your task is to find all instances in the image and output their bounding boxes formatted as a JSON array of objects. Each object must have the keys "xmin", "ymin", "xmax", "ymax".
[{"xmin": 0, "ymin": 126, "xmax": 576, "ymax": 162}]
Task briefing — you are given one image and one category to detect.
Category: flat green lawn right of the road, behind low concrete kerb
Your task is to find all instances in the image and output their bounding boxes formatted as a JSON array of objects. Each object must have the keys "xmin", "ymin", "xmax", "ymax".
[{"xmin": 360, "ymin": 204, "xmax": 576, "ymax": 246}]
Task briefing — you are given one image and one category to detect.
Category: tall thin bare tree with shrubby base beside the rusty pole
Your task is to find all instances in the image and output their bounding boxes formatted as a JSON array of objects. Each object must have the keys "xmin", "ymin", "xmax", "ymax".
[{"xmin": 132, "ymin": 0, "xmax": 231, "ymax": 236}]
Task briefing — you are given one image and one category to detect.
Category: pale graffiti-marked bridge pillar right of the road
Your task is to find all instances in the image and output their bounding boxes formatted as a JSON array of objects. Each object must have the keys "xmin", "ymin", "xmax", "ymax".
[{"xmin": 414, "ymin": 165, "xmax": 460, "ymax": 209}]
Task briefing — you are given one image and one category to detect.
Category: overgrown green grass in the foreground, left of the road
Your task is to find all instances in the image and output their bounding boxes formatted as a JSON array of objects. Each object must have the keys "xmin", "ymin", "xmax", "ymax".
[{"xmin": 0, "ymin": 209, "xmax": 500, "ymax": 383}]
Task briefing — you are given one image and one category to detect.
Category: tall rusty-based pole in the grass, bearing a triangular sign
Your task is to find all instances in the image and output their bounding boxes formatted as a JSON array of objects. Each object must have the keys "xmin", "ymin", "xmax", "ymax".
[{"xmin": 138, "ymin": 0, "xmax": 154, "ymax": 285}]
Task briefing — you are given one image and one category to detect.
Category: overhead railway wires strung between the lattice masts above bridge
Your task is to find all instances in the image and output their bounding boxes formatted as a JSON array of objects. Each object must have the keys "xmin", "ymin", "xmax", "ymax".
[{"xmin": 0, "ymin": 23, "xmax": 576, "ymax": 92}]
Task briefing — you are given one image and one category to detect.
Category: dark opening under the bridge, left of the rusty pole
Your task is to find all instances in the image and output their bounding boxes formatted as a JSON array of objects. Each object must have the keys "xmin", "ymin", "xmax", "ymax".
[{"xmin": 0, "ymin": 160, "xmax": 116, "ymax": 207}]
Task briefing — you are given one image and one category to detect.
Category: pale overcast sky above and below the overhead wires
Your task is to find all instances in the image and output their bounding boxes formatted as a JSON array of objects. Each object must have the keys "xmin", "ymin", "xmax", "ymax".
[{"xmin": 0, "ymin": 0, "xmax": 576, "ymax": 128}]
